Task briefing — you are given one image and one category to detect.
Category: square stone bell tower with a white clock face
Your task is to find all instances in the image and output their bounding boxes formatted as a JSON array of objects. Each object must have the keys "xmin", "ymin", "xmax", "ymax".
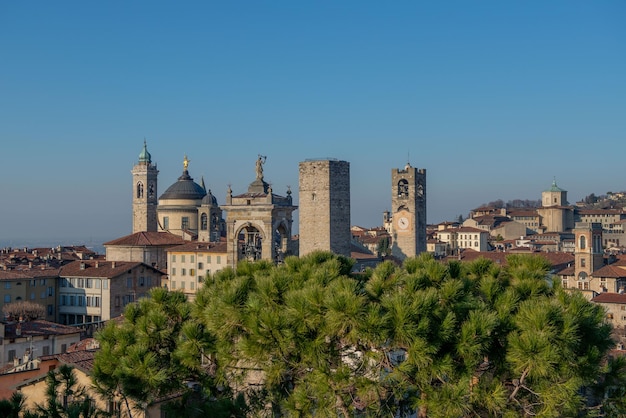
[{"xmin": 391, "ymin": 163, "xmax": 426, "ymax": 260}]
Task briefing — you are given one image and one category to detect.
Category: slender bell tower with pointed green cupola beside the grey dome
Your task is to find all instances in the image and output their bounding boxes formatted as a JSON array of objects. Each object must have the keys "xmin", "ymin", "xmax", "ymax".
[{"xmin": 131, "ymin": 140, "xmax": 159, "ymax": 234}]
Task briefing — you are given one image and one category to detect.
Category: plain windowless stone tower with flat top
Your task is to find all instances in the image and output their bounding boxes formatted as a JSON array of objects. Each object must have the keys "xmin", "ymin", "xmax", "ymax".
[{"xmin": 299, "ymin": 159, "xmax": 352, "ymax": 257}]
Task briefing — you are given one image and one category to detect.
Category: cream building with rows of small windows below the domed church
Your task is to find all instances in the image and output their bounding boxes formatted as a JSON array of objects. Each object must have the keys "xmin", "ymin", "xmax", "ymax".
[{"xmin": 167, "ymin": 242, "xmax": 228, "ymax": 300}]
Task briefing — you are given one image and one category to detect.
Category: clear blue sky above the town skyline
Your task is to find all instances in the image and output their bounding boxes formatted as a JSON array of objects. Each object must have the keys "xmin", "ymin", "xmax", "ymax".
[{"xmin": 0, "ymin": 0, "xmax": 626, "ymax": 244}]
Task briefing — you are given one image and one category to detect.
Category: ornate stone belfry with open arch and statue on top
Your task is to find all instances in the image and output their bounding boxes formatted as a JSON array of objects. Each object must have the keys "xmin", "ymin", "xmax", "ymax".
[{"xmin": 220, "ymin": 155, "xmax": 297, "ymax": 267}]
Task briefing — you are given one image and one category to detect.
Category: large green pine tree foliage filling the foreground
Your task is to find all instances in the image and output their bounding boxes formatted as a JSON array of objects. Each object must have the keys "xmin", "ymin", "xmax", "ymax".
[{"xmin": 88, "ymin": 252, "xmax": 626, "ymax": 418}]
